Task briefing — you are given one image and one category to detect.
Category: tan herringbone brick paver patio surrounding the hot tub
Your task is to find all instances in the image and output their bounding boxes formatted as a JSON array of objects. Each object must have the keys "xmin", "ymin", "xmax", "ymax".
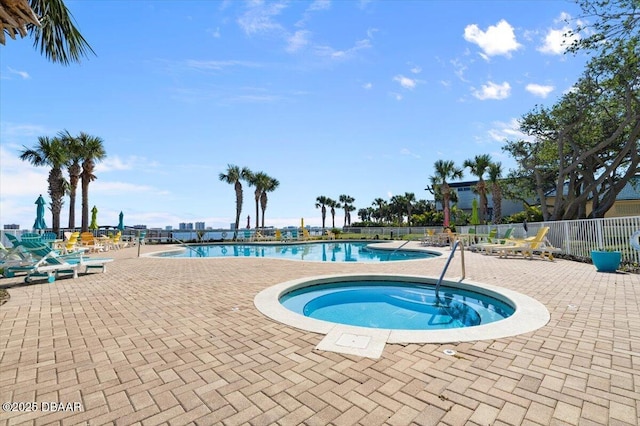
[{"xmin": 0, "ymin": 241, "xmax": 640, "ymax": 426}]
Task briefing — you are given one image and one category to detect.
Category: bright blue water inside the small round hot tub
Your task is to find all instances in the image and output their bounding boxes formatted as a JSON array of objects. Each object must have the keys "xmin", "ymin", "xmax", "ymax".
[{"xmin": 280, "ymin": 281, "xmax": 515, "ymax": 330}]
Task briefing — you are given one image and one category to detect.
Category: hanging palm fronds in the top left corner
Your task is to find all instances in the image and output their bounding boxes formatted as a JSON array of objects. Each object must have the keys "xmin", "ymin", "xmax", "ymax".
[{"xmin": 0, "ymin": 0, "xmax": 95, "ymax": 65}]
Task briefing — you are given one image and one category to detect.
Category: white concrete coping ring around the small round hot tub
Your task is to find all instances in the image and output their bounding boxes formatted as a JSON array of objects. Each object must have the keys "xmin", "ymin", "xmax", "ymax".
[{"xmin": 254, "ymin": 274, "xmax": 550, "ymax": 358}]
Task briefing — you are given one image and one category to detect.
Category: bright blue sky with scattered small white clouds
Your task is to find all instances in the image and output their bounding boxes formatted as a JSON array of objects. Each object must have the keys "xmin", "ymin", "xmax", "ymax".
[{"xmin": 0, "ymin": 0, "xmax": 585, "ymax": 229}]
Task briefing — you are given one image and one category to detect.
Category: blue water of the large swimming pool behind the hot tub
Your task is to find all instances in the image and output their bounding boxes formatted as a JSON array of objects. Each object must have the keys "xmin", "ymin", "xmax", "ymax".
[{"xmin": 152, "ymin": 242, "xmax": 439, "ymax": 262}]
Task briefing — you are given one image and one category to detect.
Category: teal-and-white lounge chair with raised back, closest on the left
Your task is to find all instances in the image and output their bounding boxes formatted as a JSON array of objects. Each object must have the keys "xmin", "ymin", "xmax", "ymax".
[{"xmin": 5, "ymin": 240, "xmax": 113, "ymax": 283}]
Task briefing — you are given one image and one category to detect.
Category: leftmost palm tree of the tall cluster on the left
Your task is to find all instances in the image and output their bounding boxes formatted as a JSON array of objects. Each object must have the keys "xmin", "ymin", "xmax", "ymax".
[{"xmin": 20, "ymin": 136, "xmax": 67, "ymax": 233}]
